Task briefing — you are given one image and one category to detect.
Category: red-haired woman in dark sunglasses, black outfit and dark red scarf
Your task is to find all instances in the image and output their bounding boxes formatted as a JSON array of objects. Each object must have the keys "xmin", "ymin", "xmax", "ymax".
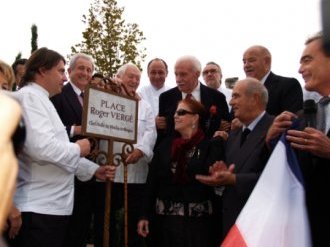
[{"xmin": 138, "ymin": 99, "xmax": 224, "ymax": 247}]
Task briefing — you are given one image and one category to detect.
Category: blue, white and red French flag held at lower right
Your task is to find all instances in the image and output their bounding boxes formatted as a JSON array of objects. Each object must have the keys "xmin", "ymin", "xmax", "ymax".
[{"xmin": 221, "ymin": 134, "xmax": 312, "ymax": 247}]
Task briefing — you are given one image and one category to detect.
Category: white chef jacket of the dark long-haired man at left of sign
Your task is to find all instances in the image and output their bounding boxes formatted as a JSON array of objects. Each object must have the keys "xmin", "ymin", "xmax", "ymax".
[{"xmin": 12, "ymin": 83, "xmax": 98, "ymax": 215}]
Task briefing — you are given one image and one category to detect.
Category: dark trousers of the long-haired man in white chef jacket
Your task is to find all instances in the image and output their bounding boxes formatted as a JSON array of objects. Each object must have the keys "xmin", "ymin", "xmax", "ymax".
[{"xmin": 9, "ymin": 212, "xmax": 69, "ymax": 247}]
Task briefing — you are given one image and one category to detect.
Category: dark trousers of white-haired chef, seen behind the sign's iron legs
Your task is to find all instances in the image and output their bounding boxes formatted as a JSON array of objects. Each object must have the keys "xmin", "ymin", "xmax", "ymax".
[{"xmin": 94, "ymin": 183, "xmax": 145, "ymax": 247}]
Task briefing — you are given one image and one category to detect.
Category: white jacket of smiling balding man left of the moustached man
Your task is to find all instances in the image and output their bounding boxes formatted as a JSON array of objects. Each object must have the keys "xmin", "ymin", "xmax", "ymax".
[{"xmin": 138, "ymin": 84, "xmax": 170, "ymax": 117}]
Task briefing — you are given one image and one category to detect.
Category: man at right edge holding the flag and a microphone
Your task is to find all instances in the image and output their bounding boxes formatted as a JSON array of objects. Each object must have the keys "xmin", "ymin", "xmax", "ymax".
[{"xmin": 266, "ymin": 33, "xmax": 330, "ymax": 246}]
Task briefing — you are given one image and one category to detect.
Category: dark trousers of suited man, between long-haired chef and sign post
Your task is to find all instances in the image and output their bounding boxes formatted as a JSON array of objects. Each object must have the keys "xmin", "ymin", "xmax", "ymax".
[{"xmin": 64, "ymin": 178, "xmax": 96, "ymax": 247}]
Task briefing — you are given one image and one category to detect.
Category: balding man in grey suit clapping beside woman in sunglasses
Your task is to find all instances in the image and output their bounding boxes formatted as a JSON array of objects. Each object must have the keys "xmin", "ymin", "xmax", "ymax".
[{"xmin": 196, "ymin": 78, "xmax": 273, "ymax": 241}]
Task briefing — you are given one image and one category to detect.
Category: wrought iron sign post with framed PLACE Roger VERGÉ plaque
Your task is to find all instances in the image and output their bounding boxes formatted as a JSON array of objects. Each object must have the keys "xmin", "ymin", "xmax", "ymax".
[{"xmin": 82, "ymin": 79, "xmax": 138, "ymax": 247}]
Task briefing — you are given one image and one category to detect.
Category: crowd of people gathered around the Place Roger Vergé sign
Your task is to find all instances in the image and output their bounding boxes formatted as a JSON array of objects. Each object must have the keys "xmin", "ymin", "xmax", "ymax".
[{"xmin": 0, "ymin": 33, "xmax": 330, "ymax": 247}]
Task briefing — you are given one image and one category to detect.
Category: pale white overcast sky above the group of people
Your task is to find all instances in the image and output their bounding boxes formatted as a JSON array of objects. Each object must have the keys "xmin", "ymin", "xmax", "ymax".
[{"xmin": 0, "ymin": 0, "xmax": 321, "ymax": 86}]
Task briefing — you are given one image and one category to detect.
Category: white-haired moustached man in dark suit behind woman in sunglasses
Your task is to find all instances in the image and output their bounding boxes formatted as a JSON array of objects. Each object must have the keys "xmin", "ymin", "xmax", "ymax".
[{"xmin": 156, "ymin": 56, "xmax": 230, "ymax": 145}]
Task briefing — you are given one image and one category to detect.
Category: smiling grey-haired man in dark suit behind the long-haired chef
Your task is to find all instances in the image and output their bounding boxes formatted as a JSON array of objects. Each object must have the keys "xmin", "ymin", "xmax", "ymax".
[{"xmin": 51, "ymin": 53, "xmax": 94, "ymax": 247}]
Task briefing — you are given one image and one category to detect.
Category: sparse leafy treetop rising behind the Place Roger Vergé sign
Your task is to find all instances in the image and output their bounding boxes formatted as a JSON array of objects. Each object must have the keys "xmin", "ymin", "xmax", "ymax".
[{"xmin": 71, "ymin": 0, "xmax": 146, "ymax": 76}]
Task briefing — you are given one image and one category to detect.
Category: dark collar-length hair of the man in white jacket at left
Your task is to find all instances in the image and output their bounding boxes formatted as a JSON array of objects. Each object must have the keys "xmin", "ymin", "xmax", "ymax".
[{"xmin": 20, "ymin": 47, "xmax": 65, "ymax": 87}]
